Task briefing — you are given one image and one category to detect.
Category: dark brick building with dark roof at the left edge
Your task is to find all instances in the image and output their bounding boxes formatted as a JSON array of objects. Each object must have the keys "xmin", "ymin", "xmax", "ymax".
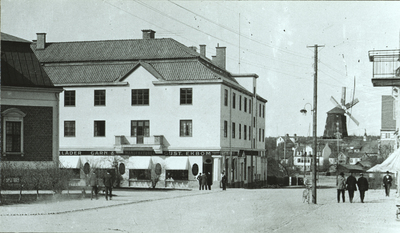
[{"xmin": 1, "ymin": 33, "xmax": 62, "ymax": 168}]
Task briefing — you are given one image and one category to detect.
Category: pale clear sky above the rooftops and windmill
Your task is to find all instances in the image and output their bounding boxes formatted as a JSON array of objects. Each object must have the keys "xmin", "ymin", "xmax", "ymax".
[{"xmin": 1, "ymin": 0, "xmax": 400, "ymax": 137}]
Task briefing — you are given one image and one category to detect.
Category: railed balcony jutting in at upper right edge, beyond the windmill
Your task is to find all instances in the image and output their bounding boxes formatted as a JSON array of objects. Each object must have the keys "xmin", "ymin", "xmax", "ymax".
[{"xmin": 368, "ymin": 49, "xmax": 400, "ymax": 87}]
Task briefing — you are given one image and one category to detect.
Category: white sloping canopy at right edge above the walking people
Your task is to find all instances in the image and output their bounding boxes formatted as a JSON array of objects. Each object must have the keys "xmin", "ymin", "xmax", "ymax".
[{"xmin": 367, "ymin": 149, "xmax": 400, "ymax": 195}]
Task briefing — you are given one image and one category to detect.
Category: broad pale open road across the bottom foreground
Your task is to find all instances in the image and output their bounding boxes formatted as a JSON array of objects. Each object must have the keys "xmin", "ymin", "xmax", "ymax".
[{"xmin": 0, "ymin": 188, "xmax": 400, "ymax": 233}]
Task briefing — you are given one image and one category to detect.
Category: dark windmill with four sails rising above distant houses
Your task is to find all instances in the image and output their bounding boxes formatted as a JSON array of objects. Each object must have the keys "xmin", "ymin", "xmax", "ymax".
[{"xmin": 323, "ymin": 87, "xmax": 360, "ymax": 139}]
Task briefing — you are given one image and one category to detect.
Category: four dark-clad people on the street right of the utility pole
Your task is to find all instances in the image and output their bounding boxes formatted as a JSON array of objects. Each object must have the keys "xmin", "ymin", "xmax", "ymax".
[{"xmin": 337, "ymin": 171, "xmax": 392, "ymax": 203}]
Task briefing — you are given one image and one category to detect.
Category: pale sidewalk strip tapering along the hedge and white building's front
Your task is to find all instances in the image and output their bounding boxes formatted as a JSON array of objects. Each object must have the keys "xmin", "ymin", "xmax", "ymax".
[{"xmin": 0, "ymin": 189, "xmax": 221, "ymax": 216}]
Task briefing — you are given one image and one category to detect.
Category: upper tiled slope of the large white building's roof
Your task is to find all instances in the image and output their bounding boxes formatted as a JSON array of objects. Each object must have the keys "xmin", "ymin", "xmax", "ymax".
[{"xmin": 31, "ymin": 38, "xmax": 200, "ymax": 62}]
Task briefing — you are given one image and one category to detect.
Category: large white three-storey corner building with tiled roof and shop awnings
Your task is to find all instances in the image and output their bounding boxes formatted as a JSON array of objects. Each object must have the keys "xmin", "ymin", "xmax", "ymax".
[{"xmin": 31, "ymin": 30, "xmax": 267, "ymax": 188}]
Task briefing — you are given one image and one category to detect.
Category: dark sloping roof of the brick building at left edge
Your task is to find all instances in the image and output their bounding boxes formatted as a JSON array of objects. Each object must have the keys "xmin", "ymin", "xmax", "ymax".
[{"xmin": 1, "ymin": 33, "xmax": 53, "ymax": 87}]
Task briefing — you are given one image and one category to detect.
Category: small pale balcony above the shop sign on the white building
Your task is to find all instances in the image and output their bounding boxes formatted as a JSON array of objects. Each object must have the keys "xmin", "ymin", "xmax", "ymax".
[{"xmin": 114, "ymin": 135, "xmax": 164, "ymax": 154}]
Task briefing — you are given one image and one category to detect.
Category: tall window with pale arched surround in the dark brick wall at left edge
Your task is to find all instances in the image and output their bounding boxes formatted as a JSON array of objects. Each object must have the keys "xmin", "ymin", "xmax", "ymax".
[{"xmin": 1, "ymin": 108, "xmax": 26, "ymax": 156}]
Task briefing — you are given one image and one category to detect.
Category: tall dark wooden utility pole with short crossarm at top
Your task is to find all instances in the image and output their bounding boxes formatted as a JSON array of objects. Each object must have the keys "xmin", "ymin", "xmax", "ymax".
[{"xmin": 307, "ymin": 44, "xmax": 325, "ymax": 204}]
